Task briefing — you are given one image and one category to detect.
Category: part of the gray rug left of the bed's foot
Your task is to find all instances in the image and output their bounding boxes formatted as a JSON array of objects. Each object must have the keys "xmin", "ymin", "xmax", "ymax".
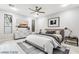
[{"xmin": 17, "ymin": 42, "xmax": 45, "ymax": 54}]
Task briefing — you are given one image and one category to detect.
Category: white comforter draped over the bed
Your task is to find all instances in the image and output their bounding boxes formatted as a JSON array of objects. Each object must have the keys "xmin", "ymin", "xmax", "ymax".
[{"xmin": 26, "ymin": 34, "xmax": 60, "ymax": 54}]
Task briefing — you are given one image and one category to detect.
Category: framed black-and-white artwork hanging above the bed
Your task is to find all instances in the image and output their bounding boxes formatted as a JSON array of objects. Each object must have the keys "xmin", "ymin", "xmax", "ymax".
[{"xmin": 48, "ymin": 17, "xmax": 60, "ymax": 27}]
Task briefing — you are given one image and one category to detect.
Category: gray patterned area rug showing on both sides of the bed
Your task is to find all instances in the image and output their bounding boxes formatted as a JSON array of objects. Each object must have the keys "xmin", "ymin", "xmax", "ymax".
[{"xmin": 17, "ymin": 42, "xmax": 69, "ymax": 54}]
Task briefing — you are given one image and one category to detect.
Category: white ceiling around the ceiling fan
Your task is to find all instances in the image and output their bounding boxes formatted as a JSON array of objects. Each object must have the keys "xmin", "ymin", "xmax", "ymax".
[{"xmin": 0, "ymin": 4, "xmax": 79, "ymax": 16}]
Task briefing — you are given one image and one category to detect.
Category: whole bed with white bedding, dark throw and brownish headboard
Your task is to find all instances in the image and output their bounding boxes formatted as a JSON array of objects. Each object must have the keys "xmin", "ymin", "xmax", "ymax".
[{"xmin": 25, "ymin": 29, "xmax": 64, "ymax": 54}]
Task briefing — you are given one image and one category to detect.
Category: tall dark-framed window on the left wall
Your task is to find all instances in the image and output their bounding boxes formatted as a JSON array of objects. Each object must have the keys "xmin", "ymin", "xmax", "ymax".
[{"xmin": 4, "ymin": 14, "xmax": 12, "ymax": 33}]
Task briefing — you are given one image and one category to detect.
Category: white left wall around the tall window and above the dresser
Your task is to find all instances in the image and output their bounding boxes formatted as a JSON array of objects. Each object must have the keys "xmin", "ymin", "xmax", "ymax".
[{"xmin": 0, "ymin": 11, "xmax": 31, "ymax": 41}]
